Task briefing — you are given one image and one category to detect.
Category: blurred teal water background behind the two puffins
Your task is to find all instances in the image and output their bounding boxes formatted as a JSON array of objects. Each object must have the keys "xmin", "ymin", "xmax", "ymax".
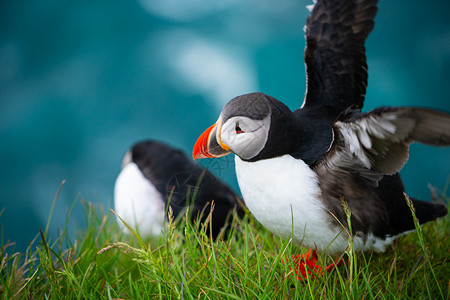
[{"xmin": 0, "ymin": 0, "xmax": 450, "ymax": 249}]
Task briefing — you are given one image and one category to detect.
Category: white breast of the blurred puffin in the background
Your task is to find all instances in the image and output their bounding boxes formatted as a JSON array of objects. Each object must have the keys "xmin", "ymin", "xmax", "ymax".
[{"xmin": 114, "ymin": 162, "xmax": 165, "ymax": 237}]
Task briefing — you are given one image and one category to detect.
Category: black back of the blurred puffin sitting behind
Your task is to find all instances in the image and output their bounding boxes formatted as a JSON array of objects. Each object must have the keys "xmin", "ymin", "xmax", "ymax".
[{"xmin": 131, "ymin": 141, "xmax": 244, "ymax": 238}]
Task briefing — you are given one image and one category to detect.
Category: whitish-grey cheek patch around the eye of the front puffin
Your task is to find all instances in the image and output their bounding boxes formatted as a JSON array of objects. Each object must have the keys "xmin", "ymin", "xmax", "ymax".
[{"xmin": 221, "ymin": 116, "xmax": 270, "ymax": 159}]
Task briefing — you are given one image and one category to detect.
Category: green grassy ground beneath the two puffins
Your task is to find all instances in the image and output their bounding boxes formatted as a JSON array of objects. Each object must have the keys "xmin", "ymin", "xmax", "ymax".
[{"xmin": 0, "ymin": 191, "xmax": 450, "ymax": 299}]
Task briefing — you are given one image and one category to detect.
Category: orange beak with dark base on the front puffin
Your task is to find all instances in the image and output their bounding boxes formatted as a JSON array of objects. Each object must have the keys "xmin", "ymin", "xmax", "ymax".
[{"xmin": 192, "ymin": 121, "xmax": 230, "ymax": 159}]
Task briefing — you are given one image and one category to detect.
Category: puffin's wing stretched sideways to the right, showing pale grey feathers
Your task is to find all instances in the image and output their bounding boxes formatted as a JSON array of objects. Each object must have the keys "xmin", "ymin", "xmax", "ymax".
[{"xmin": 335, "ymin": 107, "xmax": 450, "ymax": 175}]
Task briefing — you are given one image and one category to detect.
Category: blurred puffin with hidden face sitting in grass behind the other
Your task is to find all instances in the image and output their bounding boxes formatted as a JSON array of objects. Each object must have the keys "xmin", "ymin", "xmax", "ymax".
[{"xmin": 114, "ymin": 140, "xmax": 245, "ymax": 239}]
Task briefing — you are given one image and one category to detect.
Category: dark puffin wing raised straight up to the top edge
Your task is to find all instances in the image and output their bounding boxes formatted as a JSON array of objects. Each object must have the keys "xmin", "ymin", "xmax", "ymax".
[{"xmin": 302, "ymin": 0, "xmax": 377, "ymax": 117}]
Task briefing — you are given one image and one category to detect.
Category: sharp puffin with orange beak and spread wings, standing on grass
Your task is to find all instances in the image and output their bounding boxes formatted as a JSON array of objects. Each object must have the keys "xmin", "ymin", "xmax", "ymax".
[{"xmin": 193, "ymin": 0, "xmax": 450, "ymax": 276}]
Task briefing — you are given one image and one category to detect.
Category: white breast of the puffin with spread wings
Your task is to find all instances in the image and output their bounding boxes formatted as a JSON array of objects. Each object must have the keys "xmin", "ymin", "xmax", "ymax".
[{"xmin": 235, "ymin": 155, "xmax": 354, "ymax": 252}]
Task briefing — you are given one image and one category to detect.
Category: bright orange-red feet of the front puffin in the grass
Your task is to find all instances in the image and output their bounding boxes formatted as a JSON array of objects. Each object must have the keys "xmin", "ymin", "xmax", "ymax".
[{"xmin": 292, "ymin": 249, "xmax": 342, "ymax": 280}]
